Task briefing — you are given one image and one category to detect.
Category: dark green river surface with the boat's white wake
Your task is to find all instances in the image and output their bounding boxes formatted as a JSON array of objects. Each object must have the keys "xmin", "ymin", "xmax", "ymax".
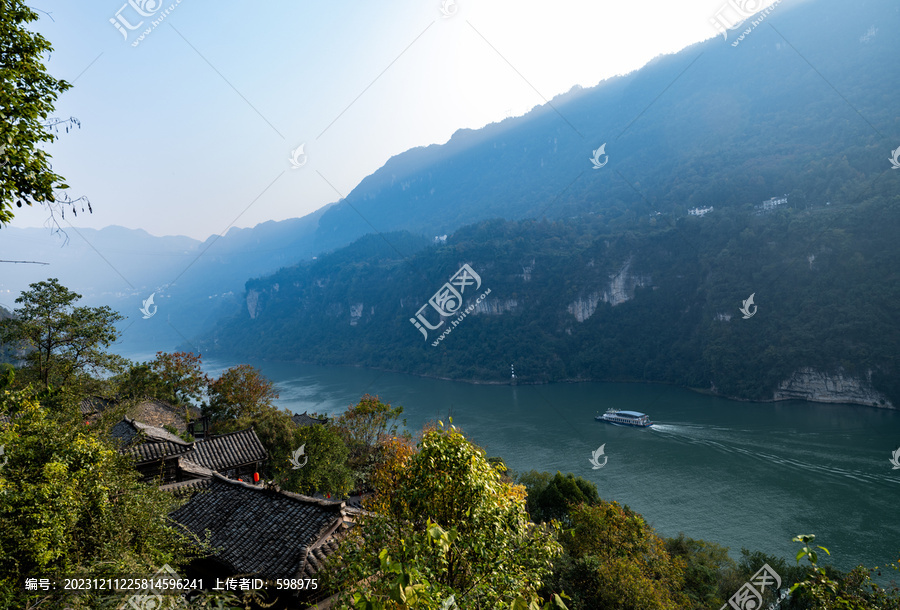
[{"xmin": 199, "ymin": 362, "xmax": 900, "ymax": 569}]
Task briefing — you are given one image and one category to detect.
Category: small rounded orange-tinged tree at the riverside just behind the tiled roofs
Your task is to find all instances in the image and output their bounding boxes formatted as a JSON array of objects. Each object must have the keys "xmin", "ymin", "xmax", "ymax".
[{"xmin": 206, "ymin": 364, "xmax": 278, "ymax": 421}]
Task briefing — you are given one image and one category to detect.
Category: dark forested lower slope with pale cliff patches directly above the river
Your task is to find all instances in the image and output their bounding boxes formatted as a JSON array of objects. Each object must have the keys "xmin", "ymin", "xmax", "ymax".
[{"xmin": 200, "ymin": 190, "xmax": 900, "ymax": 404}]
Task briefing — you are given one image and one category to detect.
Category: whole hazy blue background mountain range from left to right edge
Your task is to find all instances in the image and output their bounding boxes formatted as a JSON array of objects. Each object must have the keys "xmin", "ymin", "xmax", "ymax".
[{"xmin": 0, "ymin": 0, "xmax": 900, "ymax": 360}]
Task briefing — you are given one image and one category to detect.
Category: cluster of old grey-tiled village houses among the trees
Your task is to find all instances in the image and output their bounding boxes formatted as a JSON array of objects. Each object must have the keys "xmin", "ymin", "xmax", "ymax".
[{"xmin": 81, "ymin": 399, "xmax": 352, "ymax": 608}]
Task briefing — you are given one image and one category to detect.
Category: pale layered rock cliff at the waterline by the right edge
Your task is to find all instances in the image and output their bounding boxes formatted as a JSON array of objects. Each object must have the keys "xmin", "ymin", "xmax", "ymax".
[{"xmin": 773, "ymin": 367, "xmax": 894, "ymax": 409}]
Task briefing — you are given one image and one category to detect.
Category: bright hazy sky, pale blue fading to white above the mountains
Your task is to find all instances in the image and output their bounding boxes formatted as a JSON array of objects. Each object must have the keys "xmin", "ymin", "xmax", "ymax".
[{"xmin": 13, "ymin": 0, "xmax": 771, "ymax": 239}]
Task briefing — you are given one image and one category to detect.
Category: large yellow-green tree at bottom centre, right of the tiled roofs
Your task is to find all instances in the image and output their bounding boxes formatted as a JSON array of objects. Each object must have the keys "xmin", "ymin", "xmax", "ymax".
[{"xmin": 327, "ymin": 420, "xmax": 565, "ymax": 609}]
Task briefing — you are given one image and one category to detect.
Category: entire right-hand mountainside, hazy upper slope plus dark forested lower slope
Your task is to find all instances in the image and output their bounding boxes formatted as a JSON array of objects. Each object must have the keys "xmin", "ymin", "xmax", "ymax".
[{"xmin": 200, "ymin": 0, "xmax": 900, "ymax": 405}]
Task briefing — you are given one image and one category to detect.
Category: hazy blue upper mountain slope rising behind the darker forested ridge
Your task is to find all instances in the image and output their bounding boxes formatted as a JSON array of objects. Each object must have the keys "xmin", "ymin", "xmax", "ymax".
[{"xmin": 306, "ymin": 0, "xmax": 900, "ymax": 243}]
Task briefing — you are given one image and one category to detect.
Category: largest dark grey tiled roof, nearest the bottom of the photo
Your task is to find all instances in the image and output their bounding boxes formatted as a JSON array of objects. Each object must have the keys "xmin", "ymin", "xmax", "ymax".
[{"xmin": 170, "ymin": 474, "xmax": 344, "ymax": 579}]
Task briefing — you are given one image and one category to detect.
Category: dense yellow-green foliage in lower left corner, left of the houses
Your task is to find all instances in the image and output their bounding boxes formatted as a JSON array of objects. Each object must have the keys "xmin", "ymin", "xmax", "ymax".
[{"xmin": 0, "ymin": 391, "xmax": 200, "ymax": 607}]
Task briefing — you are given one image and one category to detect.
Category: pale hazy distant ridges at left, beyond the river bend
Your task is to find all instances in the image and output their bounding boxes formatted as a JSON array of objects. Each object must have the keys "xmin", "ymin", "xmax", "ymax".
[{"xmin": 0, "ymin": 208, "xmax": 325, "ymax": 355}]
